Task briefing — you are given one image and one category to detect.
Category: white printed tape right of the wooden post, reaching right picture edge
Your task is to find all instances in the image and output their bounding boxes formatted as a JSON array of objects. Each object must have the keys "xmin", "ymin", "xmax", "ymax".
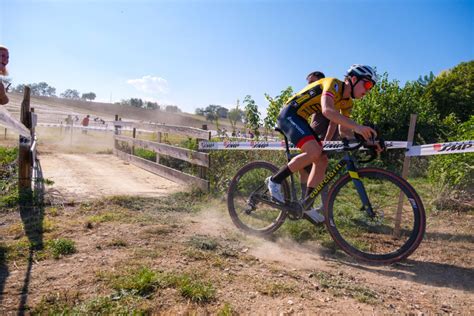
[{"xmin": 406, "ymin": 140, "xmax": 474, "ymax": 157}]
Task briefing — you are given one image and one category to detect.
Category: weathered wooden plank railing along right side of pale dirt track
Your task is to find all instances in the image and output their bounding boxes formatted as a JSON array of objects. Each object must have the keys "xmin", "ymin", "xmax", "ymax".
[{"xmin": 114, "ymin": 116, "xmax": 211, "ymax": 192}]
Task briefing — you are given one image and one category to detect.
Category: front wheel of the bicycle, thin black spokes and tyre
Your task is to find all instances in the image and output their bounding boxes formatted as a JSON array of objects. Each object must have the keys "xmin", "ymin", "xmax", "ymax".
[{"xmin": 326, "ymin": 168, "xmax": 426, "ymax": 263}]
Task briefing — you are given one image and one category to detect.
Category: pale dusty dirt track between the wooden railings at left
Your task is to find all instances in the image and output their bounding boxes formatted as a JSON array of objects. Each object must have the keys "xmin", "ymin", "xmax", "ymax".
[{"xmin": 41, "ymin": 153, "xmax": 183, "ymax": 201}]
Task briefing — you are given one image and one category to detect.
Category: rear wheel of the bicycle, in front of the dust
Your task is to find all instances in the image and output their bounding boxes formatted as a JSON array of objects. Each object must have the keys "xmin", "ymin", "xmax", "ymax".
[{"xmin": 227, "ymin": 161, "xmax": 290, "ymax": 235}]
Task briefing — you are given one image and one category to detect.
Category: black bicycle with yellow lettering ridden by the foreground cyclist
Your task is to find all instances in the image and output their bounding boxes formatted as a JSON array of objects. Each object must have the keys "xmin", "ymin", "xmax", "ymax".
[{"xmin": 227, "ymin": 129, "xmax": 426, "ymax": 264}]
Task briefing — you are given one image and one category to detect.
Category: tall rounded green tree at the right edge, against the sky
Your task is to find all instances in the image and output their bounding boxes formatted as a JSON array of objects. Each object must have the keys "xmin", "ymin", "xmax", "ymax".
[{"xmin": 426, "ymin": 60, "xmax": 474, "ymax": 122}]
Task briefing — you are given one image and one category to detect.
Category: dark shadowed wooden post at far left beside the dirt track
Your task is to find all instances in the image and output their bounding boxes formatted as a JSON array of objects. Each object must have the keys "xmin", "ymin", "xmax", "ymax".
[{"xmin": 18, "ymin": 86, "xmax": 32, "ymax": 205}]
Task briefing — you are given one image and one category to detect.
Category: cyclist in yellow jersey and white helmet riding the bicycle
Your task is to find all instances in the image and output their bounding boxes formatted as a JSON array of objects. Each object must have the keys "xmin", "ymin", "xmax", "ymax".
[{"xmin": 267, "ymin": 64, "xmax": 377, "ymax": 221}]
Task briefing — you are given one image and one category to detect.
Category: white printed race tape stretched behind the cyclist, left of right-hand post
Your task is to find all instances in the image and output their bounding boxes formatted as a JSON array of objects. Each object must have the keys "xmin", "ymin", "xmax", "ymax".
[{"xmin": 199, "ymin": 141, "xmax": 408, "ymax": 151}]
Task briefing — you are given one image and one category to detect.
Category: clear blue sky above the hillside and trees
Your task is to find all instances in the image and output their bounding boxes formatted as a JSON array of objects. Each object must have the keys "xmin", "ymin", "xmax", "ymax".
[{"xmin": 0, "ymin": 0, "xmax": 474, "ymax": 113}]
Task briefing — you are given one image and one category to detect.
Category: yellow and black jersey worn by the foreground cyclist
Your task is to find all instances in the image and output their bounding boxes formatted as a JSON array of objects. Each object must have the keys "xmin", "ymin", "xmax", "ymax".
[{"xmin": 285, "ymin": 78, "xmax": 353, "ymax": 120}]
